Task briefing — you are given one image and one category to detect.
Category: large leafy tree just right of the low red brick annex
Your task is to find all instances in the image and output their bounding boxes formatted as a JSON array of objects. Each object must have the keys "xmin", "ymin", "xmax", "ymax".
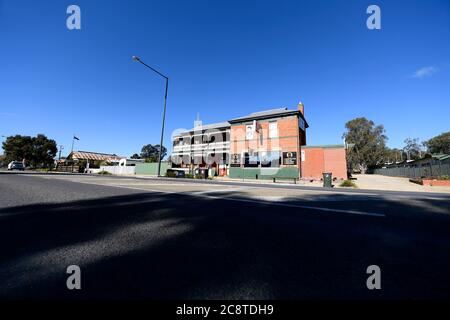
[{"xmin": 343, "ymin": 118, "xmax": 387, "ymax": 174}]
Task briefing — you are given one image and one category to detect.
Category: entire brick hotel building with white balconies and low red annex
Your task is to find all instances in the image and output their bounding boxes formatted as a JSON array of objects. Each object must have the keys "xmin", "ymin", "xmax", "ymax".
[{"xmin": 171, "ymin": 103, "xmax": 346, "ymax": 180}]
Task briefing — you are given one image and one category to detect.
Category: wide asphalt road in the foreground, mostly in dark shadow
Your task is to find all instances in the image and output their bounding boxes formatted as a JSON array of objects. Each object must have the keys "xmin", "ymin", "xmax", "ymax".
[{"xmin": 0, "ymin": 174, "xmax": 450, "ymax": 299}]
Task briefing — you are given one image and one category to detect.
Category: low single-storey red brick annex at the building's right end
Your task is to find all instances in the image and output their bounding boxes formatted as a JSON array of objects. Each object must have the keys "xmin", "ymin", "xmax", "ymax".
[{"xmin": 301, "ymin": 147, "xmax": 347, "ymax": 180}]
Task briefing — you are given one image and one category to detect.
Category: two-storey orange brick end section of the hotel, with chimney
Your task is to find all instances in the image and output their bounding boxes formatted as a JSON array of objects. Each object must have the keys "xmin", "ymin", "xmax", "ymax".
[{"xmin": 229, "ymin": 104, "xmax": 308, "ymax": 179}]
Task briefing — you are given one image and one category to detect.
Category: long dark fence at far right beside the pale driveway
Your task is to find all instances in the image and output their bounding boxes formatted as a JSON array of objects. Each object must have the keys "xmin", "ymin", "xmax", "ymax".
[{"xmin": 374, "ymin": 162, "xmax": 450, "ymax": 178}]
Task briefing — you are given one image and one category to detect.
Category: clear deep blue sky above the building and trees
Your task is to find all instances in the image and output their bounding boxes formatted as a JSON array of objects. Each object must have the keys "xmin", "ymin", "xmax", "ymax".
[{"xmin": 0, "ymin": 0, "xmax": 450, "ymax": 156}]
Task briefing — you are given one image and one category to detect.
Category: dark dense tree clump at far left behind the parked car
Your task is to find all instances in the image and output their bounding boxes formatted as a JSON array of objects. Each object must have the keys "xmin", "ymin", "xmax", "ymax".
[{"xmin": 3, "ymin": 134, "xmax": 57, "ymax": 167}]
